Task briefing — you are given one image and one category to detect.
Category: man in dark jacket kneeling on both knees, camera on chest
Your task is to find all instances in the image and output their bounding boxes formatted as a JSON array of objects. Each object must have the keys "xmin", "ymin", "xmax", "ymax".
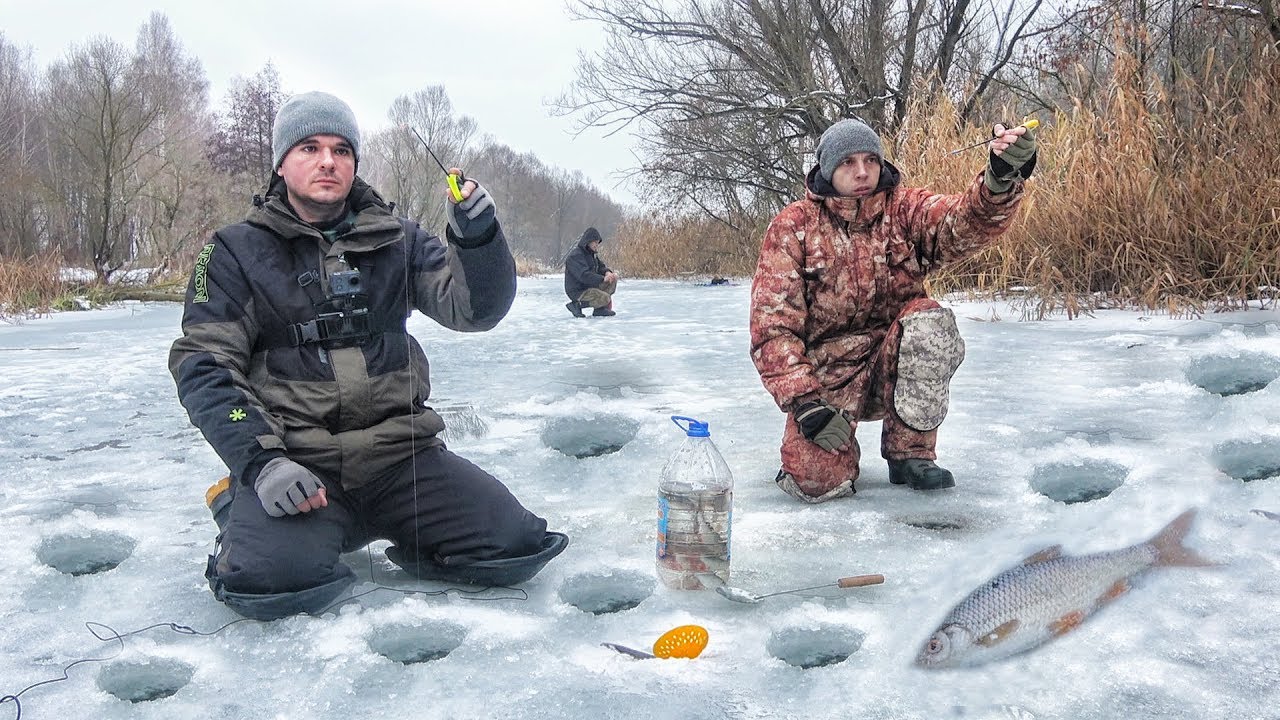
[{"xmin": 169, "ymin": 92, "xmax": 567, "ymax": 619}]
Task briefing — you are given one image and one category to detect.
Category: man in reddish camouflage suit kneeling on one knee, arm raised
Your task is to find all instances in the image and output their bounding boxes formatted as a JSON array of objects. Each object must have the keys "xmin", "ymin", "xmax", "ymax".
[{"xmin": 750, "ymin": 119, "xmax": 1036, "ymax": 502}]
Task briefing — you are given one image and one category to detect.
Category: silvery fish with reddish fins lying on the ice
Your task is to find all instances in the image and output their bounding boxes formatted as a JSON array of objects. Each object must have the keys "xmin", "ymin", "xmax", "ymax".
[{"xmin": 915, "ymin": 510, "xmax": 1215, "ymax": 669}]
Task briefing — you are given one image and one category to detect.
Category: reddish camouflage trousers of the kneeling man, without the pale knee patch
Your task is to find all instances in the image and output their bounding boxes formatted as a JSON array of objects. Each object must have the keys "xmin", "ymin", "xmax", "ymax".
[{"xmin": 782, "ymin": 297, "xmax": 957, "ymax": 500}]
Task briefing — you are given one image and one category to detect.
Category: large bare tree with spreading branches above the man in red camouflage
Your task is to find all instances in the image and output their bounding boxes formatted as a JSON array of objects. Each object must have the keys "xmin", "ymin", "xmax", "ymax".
[{"xmin": 557, "ymin": 0, "xmax": 1042, "ymax": 224}]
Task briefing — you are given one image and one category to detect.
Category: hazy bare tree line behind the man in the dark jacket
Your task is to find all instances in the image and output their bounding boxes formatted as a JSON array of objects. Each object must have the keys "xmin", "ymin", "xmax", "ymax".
[{"xmin": 0, "ymin": 13, "xmax": 623, "ymax": 282}]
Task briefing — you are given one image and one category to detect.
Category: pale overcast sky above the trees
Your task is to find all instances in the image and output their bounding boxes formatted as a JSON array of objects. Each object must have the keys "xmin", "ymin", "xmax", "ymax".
[{"xmin": 0, "ymin": 0, "xmax": 635, "ymax": 202}]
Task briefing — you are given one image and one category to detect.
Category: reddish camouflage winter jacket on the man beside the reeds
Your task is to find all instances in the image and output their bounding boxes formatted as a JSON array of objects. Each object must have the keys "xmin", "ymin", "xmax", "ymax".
[{"xmin": 750, "ymin": 161, "xmax": 1023, "ymax": 413}]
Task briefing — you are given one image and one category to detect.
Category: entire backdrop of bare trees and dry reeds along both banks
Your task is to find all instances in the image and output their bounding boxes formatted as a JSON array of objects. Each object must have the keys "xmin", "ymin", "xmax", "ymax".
[{"xmin": 0, "ymin": 0, "xmax": 1280, "ymax": 311}]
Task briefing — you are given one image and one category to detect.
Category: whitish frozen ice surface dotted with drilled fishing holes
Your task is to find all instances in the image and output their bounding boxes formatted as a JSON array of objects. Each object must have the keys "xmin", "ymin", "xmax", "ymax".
[{"xmin": 0, "ymin": 277, "xmax": 1280, "ymax": 720}]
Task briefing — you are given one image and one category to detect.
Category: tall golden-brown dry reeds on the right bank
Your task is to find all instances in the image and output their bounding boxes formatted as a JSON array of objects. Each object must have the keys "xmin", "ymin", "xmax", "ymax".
[{"xmin": 904, "ymin": 56, "xmax": 1280, "ymax": 316}]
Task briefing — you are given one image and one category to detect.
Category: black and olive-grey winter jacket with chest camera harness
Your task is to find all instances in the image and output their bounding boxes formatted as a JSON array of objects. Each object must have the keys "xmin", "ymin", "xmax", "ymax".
[{"xmin": 169, "ymin": 178, "xmax": 516, "ymax": 488}]
